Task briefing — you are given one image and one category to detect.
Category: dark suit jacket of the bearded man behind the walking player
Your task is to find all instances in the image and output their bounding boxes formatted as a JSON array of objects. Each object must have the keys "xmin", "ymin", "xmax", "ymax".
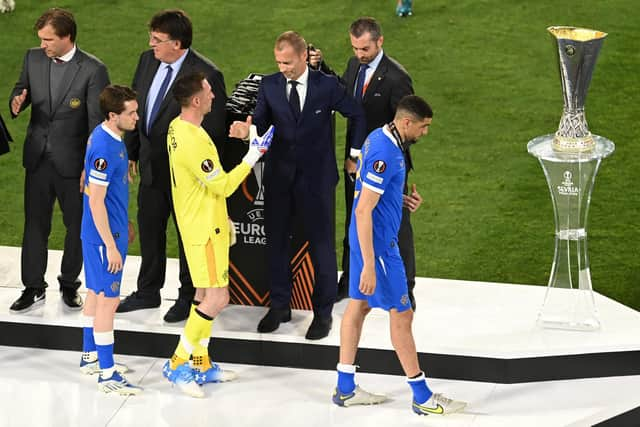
[{"xmin": 342, "ymin": 54, "xmax": 413, "ymax": 157}]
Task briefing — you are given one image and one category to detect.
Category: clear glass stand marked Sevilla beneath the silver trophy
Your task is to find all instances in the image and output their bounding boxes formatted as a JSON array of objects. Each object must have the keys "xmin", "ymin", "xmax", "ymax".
[{"xmin": 527, "ymin": 134, "xmax": 615, "ymax": 331}]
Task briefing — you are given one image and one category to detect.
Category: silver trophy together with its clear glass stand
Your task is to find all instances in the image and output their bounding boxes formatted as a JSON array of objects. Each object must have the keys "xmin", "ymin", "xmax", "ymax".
[{"xmin": 527, "ymin": 27, "xmax": 615, "ymax": 331}]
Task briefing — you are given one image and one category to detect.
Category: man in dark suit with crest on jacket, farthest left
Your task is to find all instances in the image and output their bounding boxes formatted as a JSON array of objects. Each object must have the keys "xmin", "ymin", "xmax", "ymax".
[{"xmin": 9, "ymin": 8, "xmax": 109, "ymax": 312}]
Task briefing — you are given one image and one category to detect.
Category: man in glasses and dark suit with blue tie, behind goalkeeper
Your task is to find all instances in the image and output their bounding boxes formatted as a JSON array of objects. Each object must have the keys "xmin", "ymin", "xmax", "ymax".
[{"xmin": 117, "ymin": 10, "xmax": 227, "ymax": 322}]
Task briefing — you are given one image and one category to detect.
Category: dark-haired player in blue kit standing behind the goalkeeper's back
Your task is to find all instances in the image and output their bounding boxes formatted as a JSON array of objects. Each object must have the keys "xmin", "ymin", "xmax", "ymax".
[{"xmin": 80, "ymin": 85, "xmax": 142, "ymax": 395}]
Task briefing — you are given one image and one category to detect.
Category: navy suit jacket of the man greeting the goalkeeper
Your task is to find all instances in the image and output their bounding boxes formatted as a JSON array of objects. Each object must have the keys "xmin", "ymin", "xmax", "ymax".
[{"xmin": 253, "ymin": 70, "xmax": 366, "ymax": 192}]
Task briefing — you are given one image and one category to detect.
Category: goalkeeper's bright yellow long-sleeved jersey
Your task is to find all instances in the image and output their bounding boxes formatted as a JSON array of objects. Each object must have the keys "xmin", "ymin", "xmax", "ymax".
[{"xmin": 167, "ymin": 116, "xmax": 251, "ymax": 247}]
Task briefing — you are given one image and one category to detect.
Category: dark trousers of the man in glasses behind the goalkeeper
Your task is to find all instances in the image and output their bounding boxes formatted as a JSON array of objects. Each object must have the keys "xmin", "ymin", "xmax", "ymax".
[{"xmin": 138, "ymin": 185, "xmax": 195, "ymax": 301}]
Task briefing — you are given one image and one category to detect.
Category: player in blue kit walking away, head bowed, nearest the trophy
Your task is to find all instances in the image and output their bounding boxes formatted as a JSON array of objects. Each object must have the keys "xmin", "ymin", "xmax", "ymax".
[{"xmin": 333, "ymin": 95, "xmax": 466, "ymax": 415}]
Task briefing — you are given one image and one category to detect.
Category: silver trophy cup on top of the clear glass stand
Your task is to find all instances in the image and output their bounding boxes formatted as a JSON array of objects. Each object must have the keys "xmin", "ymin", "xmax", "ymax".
[{"xmin": 547, "ymin": 27, "xmax": 607, "ymax": 153}]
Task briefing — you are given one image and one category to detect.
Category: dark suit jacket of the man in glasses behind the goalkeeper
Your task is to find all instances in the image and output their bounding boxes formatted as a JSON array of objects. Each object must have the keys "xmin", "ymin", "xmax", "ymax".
[{"xmin": 124, "ymin": 49, "xmax": 228, "ymax": 191}]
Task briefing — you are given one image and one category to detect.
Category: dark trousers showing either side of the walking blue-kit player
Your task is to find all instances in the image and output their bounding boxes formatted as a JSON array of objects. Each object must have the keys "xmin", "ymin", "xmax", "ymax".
[{"xmin": 339, "ymin": 171, "xmax": 416, "ymax": 299}]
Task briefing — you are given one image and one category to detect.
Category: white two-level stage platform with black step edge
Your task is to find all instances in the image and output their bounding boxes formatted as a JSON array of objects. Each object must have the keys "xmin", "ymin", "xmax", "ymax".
[{"xmin": 0, "ymin": 247, "xmax": 640, "ymax": 427}]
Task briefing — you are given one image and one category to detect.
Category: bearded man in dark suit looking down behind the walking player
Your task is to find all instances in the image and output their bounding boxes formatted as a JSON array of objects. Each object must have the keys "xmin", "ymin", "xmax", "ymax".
[{"xmin": 338, "ymin": 17, "xmax": 422, "ymax": 309}]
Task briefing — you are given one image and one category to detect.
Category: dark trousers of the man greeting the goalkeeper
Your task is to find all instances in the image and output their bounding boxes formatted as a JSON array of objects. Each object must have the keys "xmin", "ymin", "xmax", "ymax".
[{"xmin": 265, "ymin": 178, "xmax": 338, "ymax": 317}]
